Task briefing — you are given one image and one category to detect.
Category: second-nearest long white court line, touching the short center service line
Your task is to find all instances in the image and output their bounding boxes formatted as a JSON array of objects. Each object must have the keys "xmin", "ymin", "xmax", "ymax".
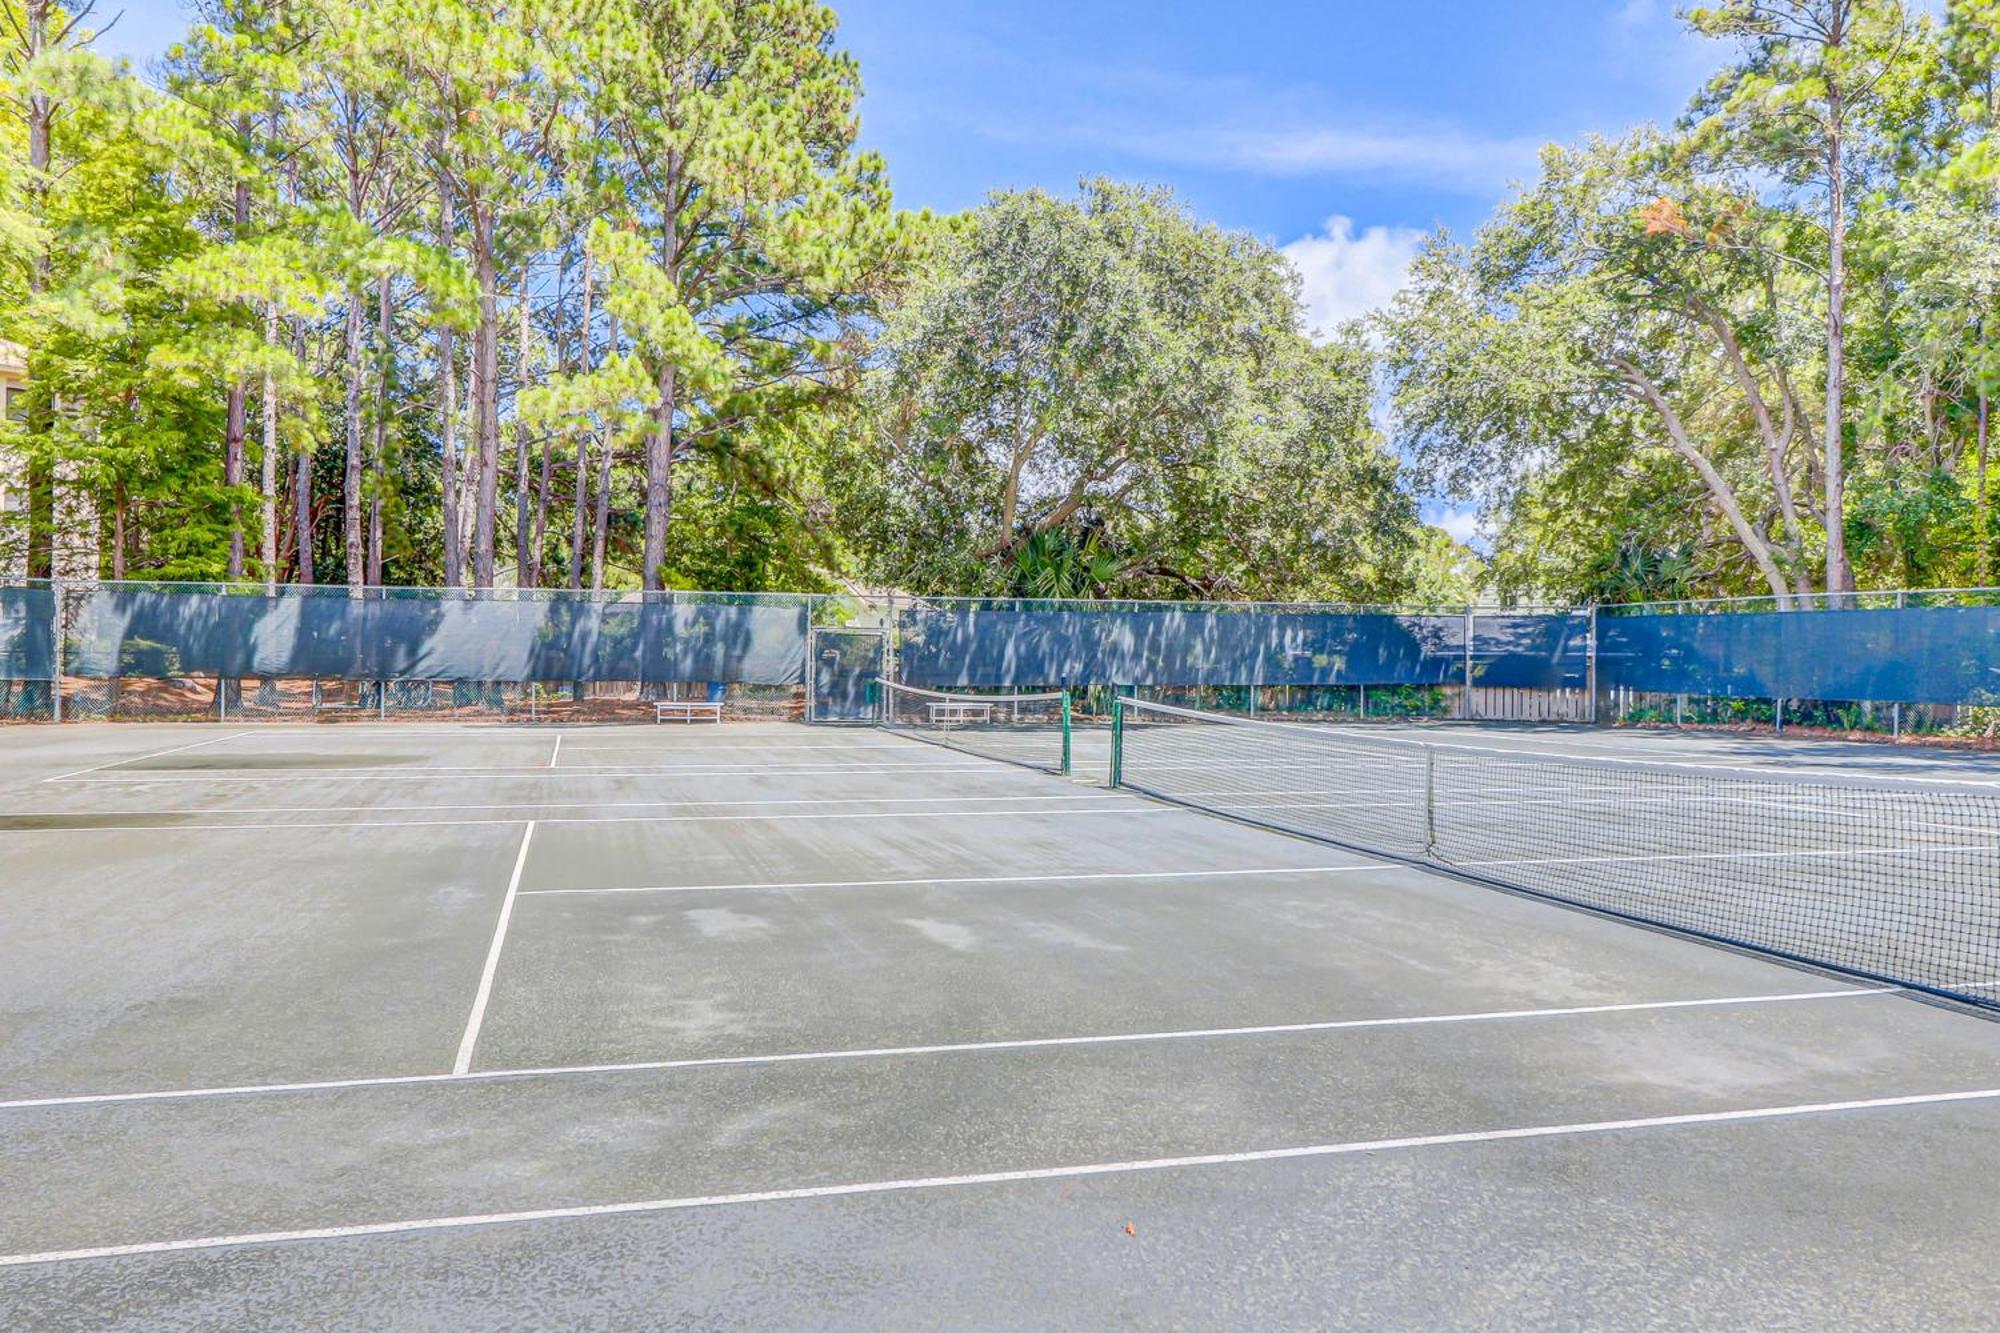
[{"xmin": 0, "ymin": 987, "xmax": 1872, "ymax": 1111}]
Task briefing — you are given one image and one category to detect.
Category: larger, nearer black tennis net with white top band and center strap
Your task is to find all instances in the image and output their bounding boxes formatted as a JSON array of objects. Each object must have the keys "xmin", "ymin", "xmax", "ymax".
[{"xmin": 1112, "ymin": 699, "xmax": 2000, "ymax": 1007}]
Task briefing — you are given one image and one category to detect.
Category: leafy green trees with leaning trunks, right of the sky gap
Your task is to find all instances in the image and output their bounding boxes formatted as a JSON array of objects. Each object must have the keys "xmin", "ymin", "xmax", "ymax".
[{"xmin": 1378, "ymin": 0, "xmax": 2000, "ymax": 598}]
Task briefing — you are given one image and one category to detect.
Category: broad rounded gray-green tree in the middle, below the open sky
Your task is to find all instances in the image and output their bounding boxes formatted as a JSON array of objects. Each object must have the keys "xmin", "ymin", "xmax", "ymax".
[{"xmin": 844, "ymin": 180, "xmax": 1416, "ymax": 596}]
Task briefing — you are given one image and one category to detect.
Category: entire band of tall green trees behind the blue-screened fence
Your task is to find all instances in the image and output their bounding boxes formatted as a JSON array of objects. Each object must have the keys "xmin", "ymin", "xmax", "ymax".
[{"xmin": 0, "ymin": 0, "xmax": 2000, "ymax": 604}]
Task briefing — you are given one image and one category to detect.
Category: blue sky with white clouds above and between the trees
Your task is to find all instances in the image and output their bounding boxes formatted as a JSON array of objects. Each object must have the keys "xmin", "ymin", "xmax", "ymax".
[{"xmin": 100, "ymin": 0, "xmax": 1726, "ymax": 534}]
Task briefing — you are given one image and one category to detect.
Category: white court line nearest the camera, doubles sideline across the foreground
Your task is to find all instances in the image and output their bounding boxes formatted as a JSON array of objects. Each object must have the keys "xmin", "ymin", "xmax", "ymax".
[{"xmin": 0, "ymin": 1087, "xmax": 2000, "ymax": 1267}]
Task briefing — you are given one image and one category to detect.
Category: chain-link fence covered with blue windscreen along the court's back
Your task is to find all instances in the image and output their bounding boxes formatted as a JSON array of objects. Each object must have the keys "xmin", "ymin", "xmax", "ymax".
[{"xmin": 11, "ymin": 582, "xmax": 2000, "ymax": 739}]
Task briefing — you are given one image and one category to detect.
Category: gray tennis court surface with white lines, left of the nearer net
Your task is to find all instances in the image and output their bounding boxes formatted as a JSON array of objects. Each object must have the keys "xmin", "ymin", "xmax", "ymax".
[{"xmin": 0, "ymin": 725, "xmax": 2000, "ymax": 1329}]
